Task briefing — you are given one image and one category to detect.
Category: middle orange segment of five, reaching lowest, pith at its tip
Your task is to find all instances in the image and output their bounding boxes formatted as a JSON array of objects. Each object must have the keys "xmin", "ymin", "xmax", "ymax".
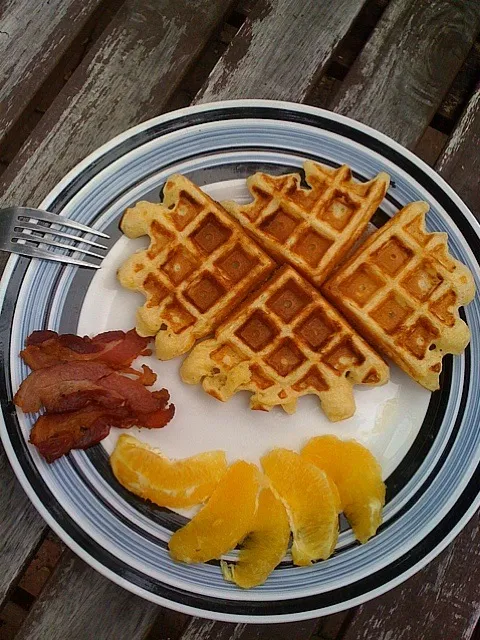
[{"xmin": 221, "ymin": 488, "xmax": 290, "ymax": 589}]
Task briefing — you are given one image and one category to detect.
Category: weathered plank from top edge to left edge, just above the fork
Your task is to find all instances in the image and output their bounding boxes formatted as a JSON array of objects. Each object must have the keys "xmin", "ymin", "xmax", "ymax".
[{"xmin": 0, "ymin": 0, "xmax": 232, "ymax": 206}]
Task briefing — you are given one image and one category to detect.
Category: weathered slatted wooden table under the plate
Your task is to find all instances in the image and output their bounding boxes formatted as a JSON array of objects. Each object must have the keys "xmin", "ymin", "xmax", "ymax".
[{"xmin": 0, "ymin": 0, "xmax": 480, "ymax": 640}]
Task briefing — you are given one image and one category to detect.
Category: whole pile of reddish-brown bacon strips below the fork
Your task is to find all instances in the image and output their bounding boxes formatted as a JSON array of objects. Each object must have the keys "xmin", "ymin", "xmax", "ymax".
[{"xmin": 14, "ymin": 331, "xmax": 175, "ymax": 462}]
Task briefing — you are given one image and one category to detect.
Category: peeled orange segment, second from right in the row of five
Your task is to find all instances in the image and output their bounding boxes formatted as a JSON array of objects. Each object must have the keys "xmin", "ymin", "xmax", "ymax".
[{"xmin": 261, "ymin": 449, "xmax": 338, "ymax": 565}]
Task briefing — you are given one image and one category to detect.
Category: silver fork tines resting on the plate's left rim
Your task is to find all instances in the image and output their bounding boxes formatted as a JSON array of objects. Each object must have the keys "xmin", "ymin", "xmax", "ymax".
[{"xmin": 0, "ymin": 207, "xmax": 110, "ymax": 269}]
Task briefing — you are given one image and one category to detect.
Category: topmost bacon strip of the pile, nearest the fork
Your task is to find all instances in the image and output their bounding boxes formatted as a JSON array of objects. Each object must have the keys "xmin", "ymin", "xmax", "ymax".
[{"xmin": 20, "ymin": 329, "xmax": 150, "ymax": 370}]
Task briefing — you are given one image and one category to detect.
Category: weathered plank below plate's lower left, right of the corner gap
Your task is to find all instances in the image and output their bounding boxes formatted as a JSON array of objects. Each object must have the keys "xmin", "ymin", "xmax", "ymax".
[{"xmin": 16, "ymin": 551, "xmax": 158, "ymax": 640}]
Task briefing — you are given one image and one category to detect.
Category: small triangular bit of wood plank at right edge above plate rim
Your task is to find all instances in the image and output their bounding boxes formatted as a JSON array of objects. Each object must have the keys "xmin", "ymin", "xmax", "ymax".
[{"xmin": 436, "ymin": 86, "xmax": 480, "ymax": 220}]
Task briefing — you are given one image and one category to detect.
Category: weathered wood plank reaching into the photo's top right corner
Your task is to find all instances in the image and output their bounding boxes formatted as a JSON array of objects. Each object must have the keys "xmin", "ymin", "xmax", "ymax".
[{"xmin": 333, "ymin": 0, "xmax": 480, "ymax": 147}]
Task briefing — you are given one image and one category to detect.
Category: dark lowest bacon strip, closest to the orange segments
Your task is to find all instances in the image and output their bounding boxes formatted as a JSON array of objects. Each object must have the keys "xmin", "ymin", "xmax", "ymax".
[{"xmin": 30, "ymin": 407, "xmax": 135, "ymax": 462}]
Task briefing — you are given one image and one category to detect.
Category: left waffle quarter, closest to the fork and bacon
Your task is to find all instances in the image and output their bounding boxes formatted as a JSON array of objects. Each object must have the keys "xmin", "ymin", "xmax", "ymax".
[{"xmin": 118, "ymin": 175, "xmax": 274, "ymax": 360}]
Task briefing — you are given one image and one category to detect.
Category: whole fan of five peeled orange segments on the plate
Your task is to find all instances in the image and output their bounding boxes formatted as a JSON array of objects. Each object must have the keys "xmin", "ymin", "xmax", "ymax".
[{"xmin": 110, "ymin": 434, "xmax": 385, "ymax": 589}]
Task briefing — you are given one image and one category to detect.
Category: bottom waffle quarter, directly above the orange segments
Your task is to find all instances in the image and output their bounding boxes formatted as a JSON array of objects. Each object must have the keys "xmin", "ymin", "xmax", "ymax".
[{"xmin": 180, "ymin": 266, "xmax": 388, "ymax": 421}]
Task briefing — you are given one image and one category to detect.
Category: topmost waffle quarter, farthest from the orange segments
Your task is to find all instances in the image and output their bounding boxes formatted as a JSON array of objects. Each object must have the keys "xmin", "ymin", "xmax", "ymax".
[{"xmin": 222, "ymin": 160, "xmax": 390, "ymax": 287}]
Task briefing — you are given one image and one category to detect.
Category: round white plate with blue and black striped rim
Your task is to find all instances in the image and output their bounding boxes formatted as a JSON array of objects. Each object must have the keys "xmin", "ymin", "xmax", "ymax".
[{"xmin": 0, "ymin": 100, "xmax": 480, "ymax": 622}]
